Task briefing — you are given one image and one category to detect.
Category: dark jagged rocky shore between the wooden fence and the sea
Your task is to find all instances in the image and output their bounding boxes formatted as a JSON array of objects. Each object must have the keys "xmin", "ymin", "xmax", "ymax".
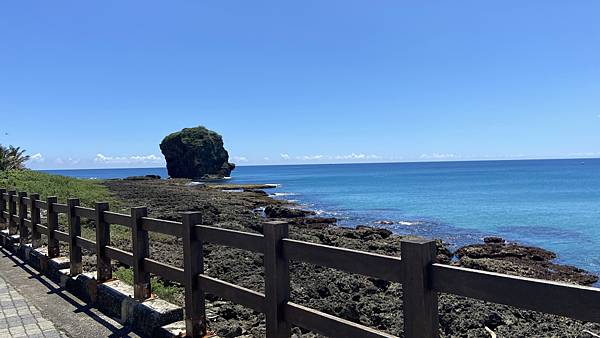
[{"xmin": 99, "ymin": 179, "xmax": 600, "ymax": 338}]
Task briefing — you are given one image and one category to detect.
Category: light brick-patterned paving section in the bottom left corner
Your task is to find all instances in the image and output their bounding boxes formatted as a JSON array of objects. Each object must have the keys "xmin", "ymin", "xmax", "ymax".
[{"xmin": 0, "ymin": 277, "xmax": 66, "ymax": 338}]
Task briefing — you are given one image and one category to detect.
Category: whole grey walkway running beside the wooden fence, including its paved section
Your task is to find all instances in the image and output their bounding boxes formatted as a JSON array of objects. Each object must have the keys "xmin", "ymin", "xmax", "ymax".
[{"xmin": 0, "ymin": 248, "xmax": 138, "ymax": 338}]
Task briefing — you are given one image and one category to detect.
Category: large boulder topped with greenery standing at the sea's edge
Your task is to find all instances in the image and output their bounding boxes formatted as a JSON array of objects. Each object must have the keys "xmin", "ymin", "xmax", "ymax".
[{"xmin": 160, "ymin": 126, "xmax": 235, "ymax": 179}]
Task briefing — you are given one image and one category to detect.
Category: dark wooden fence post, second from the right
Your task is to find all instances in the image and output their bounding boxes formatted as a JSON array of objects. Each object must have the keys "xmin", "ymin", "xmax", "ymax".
[{"xmin": 263, "ymin": 221, "xmax": 292, "ymax": 338}]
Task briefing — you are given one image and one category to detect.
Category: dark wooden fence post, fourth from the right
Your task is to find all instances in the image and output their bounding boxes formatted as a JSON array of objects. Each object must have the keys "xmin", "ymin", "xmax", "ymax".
[{"xmin": 131, "ymin": 207, "xmax": 152, "ymax": 300}]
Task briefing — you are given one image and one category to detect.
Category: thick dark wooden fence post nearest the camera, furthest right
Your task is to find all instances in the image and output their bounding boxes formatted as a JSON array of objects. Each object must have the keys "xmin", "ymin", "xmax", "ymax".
[{"xmin": 400, "ymin": 240, "xmax": 439, "ymax": 338}]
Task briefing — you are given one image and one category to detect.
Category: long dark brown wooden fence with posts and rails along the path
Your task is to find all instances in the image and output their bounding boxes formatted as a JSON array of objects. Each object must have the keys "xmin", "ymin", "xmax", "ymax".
[{"xmin": 0, "ymin": 189, "xmax": 600, "ymax": 338}]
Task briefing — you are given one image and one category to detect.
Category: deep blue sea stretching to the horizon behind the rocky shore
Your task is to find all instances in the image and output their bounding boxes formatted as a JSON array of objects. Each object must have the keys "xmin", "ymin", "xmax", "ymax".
[{"xmin": 42, "ymin": 159, "xmax": 600, "ymax": 274}]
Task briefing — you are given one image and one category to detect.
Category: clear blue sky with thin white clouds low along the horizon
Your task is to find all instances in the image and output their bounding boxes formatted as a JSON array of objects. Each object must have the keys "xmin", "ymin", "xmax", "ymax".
[{"xmin": 0, "ymin": 0, "xmax": 600, "ymax": 168}]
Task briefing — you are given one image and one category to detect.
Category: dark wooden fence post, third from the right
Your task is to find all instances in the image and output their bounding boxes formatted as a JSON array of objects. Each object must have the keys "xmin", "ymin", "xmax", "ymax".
[{"xmin": 183, "ymin": 212, "xmax": 206, "ymax": 338}]
